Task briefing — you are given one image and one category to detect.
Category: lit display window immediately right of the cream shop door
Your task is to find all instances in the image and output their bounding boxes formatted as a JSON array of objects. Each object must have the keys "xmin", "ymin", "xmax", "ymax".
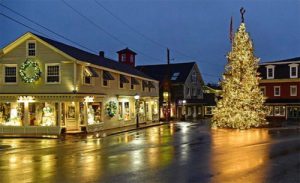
[{"xmin": 87, "ymin": 102, "xmax": 102, "ymax": 125}]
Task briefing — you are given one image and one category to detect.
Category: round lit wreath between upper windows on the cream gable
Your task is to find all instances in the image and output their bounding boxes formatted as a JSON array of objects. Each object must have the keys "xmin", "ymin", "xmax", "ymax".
[{"xmin": 19, "ymin": 59, "xmax": 42, "ymax": 83}]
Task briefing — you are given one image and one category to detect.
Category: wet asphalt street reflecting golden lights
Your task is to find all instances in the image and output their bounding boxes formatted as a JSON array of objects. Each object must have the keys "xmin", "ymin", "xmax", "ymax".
[{"xmin": 0, "ymin": 122, "xmax": 300, "ymax": 183}]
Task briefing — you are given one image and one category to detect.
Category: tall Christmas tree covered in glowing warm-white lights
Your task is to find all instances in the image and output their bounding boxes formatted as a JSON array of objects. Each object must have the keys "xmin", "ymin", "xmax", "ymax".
[{"xmin": 212, "ymin": 9, "xmax": 266, "ymax": 129}]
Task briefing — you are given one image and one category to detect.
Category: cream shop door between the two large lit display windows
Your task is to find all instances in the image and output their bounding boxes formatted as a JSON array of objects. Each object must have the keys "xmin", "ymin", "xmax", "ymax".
[{"xmin": 66, "ymin": 102, "xmax": 78, "ymax": 130}]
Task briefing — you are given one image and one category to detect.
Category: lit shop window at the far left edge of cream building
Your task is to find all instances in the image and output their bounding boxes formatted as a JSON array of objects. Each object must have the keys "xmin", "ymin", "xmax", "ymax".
[{"xmin": 0, "ymin": 102, "xmax": 24, "ymax": 126}]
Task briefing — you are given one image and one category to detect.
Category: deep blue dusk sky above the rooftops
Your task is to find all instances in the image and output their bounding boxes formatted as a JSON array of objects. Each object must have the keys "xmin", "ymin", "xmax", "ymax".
[{"xmin": 0, "ymin": 0, "xmax": 300, "ymax": 82}]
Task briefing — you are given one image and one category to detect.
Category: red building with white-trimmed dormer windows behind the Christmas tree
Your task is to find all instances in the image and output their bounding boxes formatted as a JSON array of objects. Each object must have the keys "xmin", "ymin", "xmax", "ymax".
[{"xmin": 258, "ymin": 57, "xmax": 300, "ymax": 122}]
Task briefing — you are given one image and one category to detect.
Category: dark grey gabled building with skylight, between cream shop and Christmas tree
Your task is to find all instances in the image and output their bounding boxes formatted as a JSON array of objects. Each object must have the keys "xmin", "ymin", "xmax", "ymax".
[{"xmin": 137, "ymin": 62, "xmax": 211, "ymax": 119}]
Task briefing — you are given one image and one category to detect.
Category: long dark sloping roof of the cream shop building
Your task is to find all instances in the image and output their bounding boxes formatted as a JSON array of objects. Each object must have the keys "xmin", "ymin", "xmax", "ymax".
[{"xmin": 34, "ymin": 34, "xmax": 153, "ymax": 79}]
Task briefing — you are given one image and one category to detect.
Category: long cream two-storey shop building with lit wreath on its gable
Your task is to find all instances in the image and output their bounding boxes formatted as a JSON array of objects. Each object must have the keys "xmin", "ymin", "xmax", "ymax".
[{"xmin": 0, "ymin": 32, "xmax": 159, "ymax": 134}]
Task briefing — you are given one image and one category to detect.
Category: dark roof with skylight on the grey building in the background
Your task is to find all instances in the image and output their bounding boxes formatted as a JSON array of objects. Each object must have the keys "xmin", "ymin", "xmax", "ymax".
[{"xmin": 136, "ymin": 62, "xmax": 196, "ymax": 84}]
